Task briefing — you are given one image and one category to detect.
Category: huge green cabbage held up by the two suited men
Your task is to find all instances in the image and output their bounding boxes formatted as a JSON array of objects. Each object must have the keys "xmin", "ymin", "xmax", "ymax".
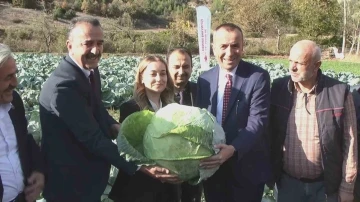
[{"xmin": 117, "ymin": 103, "xmax": 225, "ymax": 184}]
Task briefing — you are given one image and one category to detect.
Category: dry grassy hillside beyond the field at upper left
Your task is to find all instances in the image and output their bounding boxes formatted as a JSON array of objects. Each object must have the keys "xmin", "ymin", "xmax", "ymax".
[{"xmin": 0, "ymin": 1, "xmax": 187, "ymax": 54}]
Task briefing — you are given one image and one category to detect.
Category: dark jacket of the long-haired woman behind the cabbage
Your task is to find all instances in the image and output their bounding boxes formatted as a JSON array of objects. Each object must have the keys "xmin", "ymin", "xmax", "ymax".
[{"xmin": 109, "ymin": 99, "xmax": 176, "ymax": 202}]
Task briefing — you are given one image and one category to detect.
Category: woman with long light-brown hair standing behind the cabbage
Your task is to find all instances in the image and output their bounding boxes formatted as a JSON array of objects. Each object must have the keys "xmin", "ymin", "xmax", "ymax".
[{"xmin": 109, "ymin": 56, "xmax": 179, "ymax": 202}]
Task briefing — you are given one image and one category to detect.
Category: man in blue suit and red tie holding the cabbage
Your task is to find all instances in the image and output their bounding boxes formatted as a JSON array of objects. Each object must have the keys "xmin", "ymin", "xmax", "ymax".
[{"xmin": 197, "ymin": 23, "xmax": 270, "ymax": 202}]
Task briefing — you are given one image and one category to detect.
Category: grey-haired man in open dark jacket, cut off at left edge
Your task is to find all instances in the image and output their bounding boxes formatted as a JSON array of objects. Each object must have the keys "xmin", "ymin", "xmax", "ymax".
[{"xmin": 0, "ymin": 44, "xmax": 44, "ymax": 202}]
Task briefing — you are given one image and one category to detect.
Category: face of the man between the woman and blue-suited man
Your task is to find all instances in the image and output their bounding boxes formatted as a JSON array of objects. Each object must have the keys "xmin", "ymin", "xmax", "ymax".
[{"xmin": 168, "ymin": 51, "xmax": 192, "ymax": 88}]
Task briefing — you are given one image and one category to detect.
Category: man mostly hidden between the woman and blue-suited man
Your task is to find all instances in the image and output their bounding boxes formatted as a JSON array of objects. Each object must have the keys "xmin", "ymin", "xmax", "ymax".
[{"xmin": 166, "ymin": 48, "xmax": 202, "ymax": 202}]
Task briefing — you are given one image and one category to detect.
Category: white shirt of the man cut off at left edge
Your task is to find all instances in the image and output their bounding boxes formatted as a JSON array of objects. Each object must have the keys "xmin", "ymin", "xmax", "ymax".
[{"xmin": 0, "ymin": 103, "xmax": 25, "ymax": 202}]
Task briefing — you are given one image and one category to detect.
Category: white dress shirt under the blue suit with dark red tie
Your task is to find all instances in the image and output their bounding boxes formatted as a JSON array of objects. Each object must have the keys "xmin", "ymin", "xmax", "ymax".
[{"xmin": 216, "ymin": 66, "xmax": 238, "ymax": 125}]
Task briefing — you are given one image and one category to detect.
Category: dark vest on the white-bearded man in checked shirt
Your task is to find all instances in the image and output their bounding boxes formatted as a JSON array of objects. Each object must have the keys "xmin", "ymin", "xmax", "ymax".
[{"xmin": 269, "ymin": 71, "xmax": 349, "ymax": 194}]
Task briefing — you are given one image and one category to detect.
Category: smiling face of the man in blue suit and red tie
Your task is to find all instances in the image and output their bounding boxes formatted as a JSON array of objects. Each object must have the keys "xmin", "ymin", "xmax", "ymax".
[{"xmin": 213, "ymin": 27, "xmax": 243, "ymax": 71}]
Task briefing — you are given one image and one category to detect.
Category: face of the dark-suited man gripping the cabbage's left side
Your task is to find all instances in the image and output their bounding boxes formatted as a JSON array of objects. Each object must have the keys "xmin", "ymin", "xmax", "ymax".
[{"xmin": 66, "ymin": 22, "xmax": 104, "ymax": 69}]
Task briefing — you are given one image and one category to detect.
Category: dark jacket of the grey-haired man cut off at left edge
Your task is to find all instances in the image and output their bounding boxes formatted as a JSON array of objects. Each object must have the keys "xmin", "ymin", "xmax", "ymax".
[{"xmin": 0, "ymin": 91, "xmax": 44, "ymax": 201}]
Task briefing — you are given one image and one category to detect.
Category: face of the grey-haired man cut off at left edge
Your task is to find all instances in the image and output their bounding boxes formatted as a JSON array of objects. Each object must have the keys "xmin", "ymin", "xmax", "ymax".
[{"xmin": 0, "ymin": 57, "xmax": 18, "ymax": 104}]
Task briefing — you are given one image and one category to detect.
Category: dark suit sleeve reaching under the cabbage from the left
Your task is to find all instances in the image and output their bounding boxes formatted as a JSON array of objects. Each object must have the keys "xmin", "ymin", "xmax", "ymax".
[{"xmin": 50, "ymin": 82, "xmax": 137, "ymax": 174}]
